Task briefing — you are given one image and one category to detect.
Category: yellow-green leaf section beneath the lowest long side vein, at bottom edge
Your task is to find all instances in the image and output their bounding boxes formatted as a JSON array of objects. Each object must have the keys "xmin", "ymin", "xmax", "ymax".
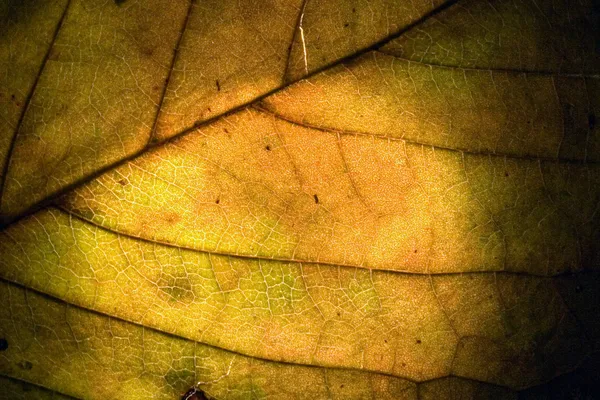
[{"xmin": 0, "ymin": 282, "xmax": 416, "ymax": 400}]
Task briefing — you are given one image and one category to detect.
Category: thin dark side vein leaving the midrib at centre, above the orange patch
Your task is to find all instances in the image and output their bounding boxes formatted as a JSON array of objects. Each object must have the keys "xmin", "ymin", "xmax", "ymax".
[{"xmin": 251, "ymin": 104, "xmax": 600, "ymax": 166}]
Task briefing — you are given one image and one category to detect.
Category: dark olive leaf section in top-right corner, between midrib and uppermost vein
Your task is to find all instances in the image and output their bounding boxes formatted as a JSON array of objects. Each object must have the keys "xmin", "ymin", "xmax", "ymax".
[{"xmin": 382, "ymin": 0, "xmax": 600, "ymax": 75}]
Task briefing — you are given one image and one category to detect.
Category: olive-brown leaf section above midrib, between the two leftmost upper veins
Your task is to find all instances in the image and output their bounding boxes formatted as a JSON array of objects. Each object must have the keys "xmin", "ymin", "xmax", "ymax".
[{"xmin": 1, "ymin": 0, "xmax": 188, "ymax": 216}]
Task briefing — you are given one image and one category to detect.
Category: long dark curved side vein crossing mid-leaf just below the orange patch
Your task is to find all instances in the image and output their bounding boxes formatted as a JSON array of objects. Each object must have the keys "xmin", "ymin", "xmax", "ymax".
[{"xmin": 49, "ymin": 204, "xmax": 586, "ymax": 279}]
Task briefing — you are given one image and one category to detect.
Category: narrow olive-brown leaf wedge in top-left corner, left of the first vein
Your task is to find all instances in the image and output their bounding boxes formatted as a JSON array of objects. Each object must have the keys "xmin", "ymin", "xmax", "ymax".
[{"xmin": 0, "ymin": 0, "xmax": 67, "ymax": 190}]
